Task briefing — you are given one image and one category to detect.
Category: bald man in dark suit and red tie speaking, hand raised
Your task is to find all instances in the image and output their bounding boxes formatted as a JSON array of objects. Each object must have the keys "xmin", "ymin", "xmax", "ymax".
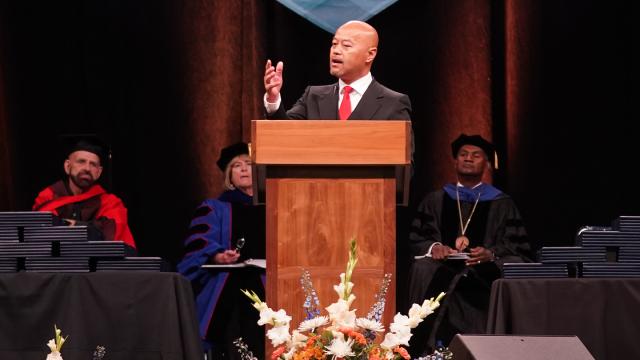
[{"xmin": 264, "ymin": 21, "xmax": 411, "ymax": 120}]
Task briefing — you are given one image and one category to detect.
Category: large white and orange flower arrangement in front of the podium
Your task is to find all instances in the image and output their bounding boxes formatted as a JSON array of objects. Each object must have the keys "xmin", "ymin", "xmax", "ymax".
[{"xmin": 243, "ymin": 239, "xmax": 444, "ymax": 360}]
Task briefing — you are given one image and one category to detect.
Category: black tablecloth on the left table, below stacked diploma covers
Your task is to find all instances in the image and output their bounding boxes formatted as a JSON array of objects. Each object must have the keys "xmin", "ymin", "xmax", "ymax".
[{"xmin": 0, "ymin": 272, "xmax": 202, "ymax": 360}]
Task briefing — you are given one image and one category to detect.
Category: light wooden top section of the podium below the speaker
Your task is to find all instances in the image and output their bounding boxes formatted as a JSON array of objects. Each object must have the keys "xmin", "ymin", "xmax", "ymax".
[{"xmin": 251, "ymin": 120, "xmax": 411, "ymax": 165}]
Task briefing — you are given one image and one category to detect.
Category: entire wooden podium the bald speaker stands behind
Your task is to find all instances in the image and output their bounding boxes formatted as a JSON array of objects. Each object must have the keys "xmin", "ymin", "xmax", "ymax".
[{"xmin": 251, "ymin": 120, "xmax": 411, "ymax": 329}]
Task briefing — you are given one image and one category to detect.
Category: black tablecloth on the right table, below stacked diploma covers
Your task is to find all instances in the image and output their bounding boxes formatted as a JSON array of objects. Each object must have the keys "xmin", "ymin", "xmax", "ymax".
[{"xmin": 487, "ymin": 278, "xmax": 640, "ymax": 360}]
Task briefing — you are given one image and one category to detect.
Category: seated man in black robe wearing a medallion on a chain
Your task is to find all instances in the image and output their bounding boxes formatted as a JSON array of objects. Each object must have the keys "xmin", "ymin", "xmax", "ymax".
[{"xmin": 409, "ymin": 134, "xmax": 532, "ymax": 356}]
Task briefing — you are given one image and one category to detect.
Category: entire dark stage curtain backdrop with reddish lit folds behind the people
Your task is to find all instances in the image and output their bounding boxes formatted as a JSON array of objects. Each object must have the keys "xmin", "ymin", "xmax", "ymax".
[{"xmin": 0, "ymin": 0, "xmax": 640, "ymax": 266}]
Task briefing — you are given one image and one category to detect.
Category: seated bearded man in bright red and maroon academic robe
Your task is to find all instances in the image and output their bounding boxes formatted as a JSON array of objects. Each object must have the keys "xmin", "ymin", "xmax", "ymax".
[{"xmin": 33, "ymin": 136, "xmax": 136, "ymax": 249}]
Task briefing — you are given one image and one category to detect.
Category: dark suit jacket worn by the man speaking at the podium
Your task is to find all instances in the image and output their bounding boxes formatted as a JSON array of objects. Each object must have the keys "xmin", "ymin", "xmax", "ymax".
[{"xmin": 267, "ymin": 79, "xmax": 411, "ymax": 120}]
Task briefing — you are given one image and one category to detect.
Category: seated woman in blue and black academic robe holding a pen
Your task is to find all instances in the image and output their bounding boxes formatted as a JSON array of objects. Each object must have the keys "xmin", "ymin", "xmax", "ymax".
[{"xmin": 178, "ymin": 143, "xmax": 265, "ymax": 359}]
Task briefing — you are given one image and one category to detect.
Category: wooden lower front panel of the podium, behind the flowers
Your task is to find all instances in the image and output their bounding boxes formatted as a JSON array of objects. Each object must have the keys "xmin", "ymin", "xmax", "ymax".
[{"xmin": 267, "ymin": 179, "xmax": 395, "ymax": 325}]
